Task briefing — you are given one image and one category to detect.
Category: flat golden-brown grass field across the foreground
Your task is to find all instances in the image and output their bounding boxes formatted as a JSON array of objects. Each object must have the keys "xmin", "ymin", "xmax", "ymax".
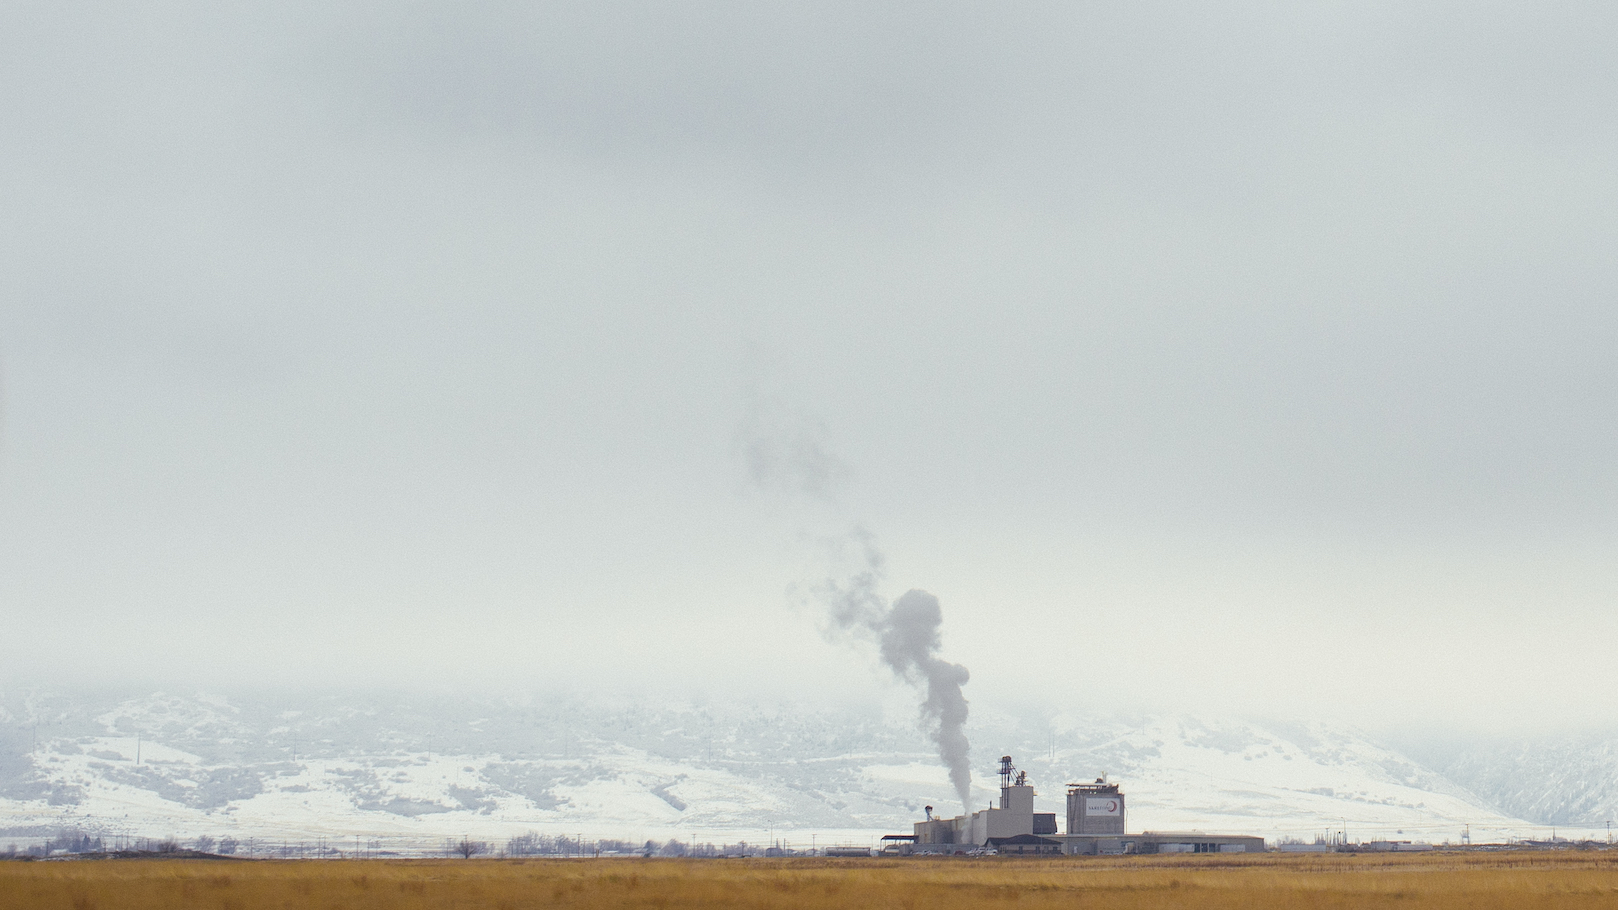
[{"xmin": 0, "ymin": 852, "xmax": 1618, "ymax": 910}]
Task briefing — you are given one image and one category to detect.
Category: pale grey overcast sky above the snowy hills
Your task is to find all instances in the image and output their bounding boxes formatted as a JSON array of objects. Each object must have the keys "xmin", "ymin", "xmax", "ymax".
[{"xmin": 0, "ymin": 0, "xmax": 1618, "ymax": 729}]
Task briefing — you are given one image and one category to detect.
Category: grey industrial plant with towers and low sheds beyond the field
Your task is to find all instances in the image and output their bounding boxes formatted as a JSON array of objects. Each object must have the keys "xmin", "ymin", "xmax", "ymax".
[{"xmin": 883, "ymin": 755, "xmax": 1264, "ymax": 855}]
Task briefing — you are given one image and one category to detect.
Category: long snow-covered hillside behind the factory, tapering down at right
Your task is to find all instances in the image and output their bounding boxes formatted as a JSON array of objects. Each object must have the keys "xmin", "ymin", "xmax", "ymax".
[{"xmin": 0, "ymin": 693, "xmax": 1579, "ymax": 844}]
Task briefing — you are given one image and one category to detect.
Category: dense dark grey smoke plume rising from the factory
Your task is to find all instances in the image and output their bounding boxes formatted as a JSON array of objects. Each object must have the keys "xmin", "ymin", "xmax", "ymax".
[{"xmin": 820, "ymin": 533, "xmax": 972, "ymax": 811}]
